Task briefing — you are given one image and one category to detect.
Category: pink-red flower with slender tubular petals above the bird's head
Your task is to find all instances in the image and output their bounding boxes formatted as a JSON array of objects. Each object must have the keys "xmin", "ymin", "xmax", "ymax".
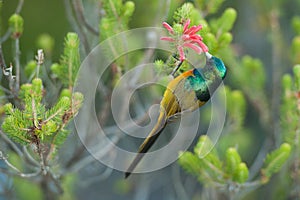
[{"xmin": 160, "ymin": 19, "xmax": 208, "ymax": 61}]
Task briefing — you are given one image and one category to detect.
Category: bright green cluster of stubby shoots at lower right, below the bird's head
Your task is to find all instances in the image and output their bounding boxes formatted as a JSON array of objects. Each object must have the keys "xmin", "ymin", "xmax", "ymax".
[{"xmin": 179, "ymin": 136, "xmax": 249, "ymax": 187}]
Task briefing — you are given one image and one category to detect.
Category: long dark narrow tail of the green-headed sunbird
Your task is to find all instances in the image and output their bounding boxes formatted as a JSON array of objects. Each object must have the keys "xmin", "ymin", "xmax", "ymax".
[{"xmin": 125, "ymin": 111, "xmax": 167, "ymax": 178}]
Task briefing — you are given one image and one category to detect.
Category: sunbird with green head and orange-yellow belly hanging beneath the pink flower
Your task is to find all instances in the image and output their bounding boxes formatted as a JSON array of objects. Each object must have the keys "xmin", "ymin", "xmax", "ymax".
[{"xmin": 125, "ymin": 52, "xmax": 227, "ymax": 178}]
